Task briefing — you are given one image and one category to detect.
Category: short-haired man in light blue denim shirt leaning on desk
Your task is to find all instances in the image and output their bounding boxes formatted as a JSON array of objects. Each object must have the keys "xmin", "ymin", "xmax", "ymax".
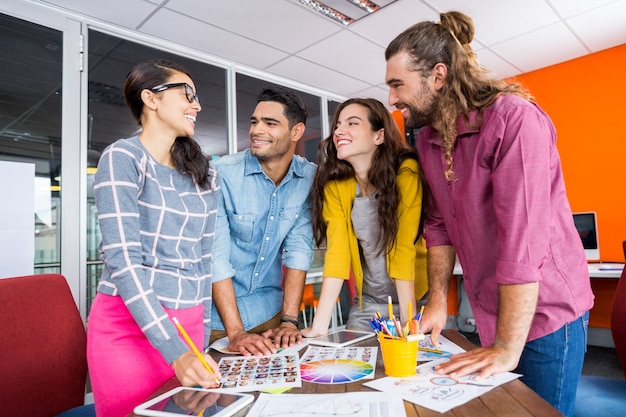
[{"xmin": 211, "ymin": 88, "xmax": 316, "ymax": 355}]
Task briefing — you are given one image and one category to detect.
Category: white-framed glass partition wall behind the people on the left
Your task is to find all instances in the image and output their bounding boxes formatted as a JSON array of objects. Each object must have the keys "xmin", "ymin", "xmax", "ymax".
[{"xmin": 0, "ymin": 8, "xmax": 336, "ymax": 314}]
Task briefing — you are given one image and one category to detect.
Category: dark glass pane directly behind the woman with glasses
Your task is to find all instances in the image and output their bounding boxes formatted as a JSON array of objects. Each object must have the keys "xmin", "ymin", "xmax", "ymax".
[{"xmin": 87, "ymin": 30, "xmax": 228, "ymax": 311}]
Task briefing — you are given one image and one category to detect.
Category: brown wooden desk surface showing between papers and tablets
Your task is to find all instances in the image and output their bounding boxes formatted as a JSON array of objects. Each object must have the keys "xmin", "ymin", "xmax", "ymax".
[{"xmin": 131, "ymin": 329, "xmax": 562, "ymax": 417}]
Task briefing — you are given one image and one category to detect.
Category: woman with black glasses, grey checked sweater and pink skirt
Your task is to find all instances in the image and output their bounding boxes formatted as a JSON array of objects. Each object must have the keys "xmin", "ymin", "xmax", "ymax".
[{"xmin": 87, "ymin": 60, "xmax": 219, "ymax": 417}]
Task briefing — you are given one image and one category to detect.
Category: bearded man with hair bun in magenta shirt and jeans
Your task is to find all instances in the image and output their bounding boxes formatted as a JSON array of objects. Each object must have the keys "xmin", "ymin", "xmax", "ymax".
[{"xmin": 385, "ymin": 11, "xmax": 593, "ymax": 416}]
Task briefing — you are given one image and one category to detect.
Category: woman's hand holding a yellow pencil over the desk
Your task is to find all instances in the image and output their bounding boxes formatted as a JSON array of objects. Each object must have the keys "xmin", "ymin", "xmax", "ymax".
[{"xmin": 172, "ymin": 317, "xmax": 221, "ymax": 388}]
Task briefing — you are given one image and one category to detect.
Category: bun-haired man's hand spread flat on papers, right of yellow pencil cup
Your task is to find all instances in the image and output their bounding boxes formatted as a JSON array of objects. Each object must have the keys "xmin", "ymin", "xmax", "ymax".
[{"xmin": 435, "ymin": 346, "xmax": 520, "ymax": 381}]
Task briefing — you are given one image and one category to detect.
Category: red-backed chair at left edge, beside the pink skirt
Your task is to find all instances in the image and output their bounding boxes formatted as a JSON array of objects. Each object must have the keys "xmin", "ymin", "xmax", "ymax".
[{"xmin": 0, "ymin": 274, "xmax": 95, "ymax": 417}]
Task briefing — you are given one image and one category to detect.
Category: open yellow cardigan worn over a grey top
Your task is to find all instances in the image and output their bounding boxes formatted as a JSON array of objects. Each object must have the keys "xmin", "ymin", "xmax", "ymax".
[{"xmin": 322, "ymin": 159, "xmax": 428, "ymax": 306}]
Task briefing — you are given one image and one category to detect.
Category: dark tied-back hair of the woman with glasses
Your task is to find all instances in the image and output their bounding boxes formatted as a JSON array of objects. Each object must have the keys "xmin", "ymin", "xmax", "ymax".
[{"xmin": 124, "ymin": 59, "xmax": 210, "ymax": 188}]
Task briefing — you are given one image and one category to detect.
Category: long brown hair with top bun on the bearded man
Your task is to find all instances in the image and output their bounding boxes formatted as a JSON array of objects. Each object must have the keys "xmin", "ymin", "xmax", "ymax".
[{"xmin": 385, "ymin": 11, "xmax": 532, "ymax": 180}]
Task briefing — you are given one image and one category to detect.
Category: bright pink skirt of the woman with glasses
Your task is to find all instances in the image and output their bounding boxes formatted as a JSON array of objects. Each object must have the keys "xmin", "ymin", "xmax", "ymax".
[{"xmin": 87, "ymin": 293, "xmax": 204, "ymax": 417}]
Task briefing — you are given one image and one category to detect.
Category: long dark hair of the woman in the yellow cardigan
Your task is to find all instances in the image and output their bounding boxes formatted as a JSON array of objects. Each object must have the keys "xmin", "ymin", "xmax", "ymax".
[{"xmin": 311, "ymin": 98, "xmax": 425, "ymax": 254}]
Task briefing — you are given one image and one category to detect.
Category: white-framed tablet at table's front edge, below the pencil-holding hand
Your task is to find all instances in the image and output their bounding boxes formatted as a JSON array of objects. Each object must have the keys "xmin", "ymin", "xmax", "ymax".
[{"xmin": 134, "ymin": 387, "xmax": 254, "ymax": 417}]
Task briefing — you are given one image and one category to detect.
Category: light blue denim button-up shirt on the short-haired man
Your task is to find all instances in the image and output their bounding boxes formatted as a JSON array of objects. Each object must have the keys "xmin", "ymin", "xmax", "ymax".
[{"xmin": 211, "ymin": 150, "xmax": 316, "ymax": 330}]
